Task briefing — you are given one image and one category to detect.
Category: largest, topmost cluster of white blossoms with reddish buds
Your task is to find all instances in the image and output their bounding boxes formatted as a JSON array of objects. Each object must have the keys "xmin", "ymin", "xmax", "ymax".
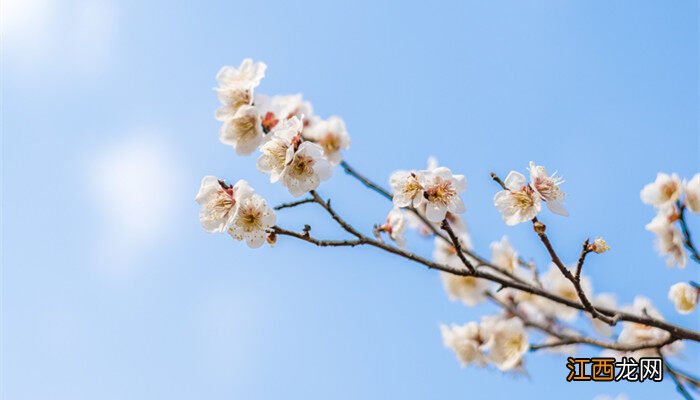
[{"xmin": 216, "ymin": 59, "xmax": 350, "ymax": 197}]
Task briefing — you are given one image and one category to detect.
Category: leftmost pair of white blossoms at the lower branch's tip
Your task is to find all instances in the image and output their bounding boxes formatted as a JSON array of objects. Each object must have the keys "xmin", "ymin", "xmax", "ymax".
[{"xmin": 196, "ymin": 176, "xmax": 276, "ymax": 248}]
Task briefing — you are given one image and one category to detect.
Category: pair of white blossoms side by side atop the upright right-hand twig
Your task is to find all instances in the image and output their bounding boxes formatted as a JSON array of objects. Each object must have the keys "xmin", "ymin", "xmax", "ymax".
[{"xmin": 493, "ymin": 161, "xmax": 569, "ymax": 225}]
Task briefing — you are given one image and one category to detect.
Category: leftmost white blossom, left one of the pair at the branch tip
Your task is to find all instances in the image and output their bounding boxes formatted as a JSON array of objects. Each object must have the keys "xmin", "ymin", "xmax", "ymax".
[{"xmin": 195, "ymin": 176, "xmax": 253, "ymax": 232}]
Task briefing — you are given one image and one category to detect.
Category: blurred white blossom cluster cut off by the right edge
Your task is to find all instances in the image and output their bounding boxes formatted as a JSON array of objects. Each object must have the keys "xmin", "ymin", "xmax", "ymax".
[{"xmin": 640, "ymin": 172, "xmax": 700, "ymax": 268}]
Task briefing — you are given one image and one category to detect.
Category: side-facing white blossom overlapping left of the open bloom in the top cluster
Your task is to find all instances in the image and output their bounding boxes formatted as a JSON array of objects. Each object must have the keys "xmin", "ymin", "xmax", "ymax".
[{"xmin": 257, "ymin": 117, "xmax": 303, "ymax": 183}]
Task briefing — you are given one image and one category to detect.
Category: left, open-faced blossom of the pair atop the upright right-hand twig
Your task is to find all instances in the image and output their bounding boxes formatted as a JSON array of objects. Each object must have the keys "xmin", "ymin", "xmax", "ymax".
[{"xmin": 493, "ymin": 171, "xmax": 542, "ymax": 225}]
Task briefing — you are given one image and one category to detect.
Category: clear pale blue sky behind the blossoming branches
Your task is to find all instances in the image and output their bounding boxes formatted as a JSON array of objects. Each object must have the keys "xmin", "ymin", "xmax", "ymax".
[{"xmin": 0, "ymin": 0, "xmax": 700, "ymax": 400}]
